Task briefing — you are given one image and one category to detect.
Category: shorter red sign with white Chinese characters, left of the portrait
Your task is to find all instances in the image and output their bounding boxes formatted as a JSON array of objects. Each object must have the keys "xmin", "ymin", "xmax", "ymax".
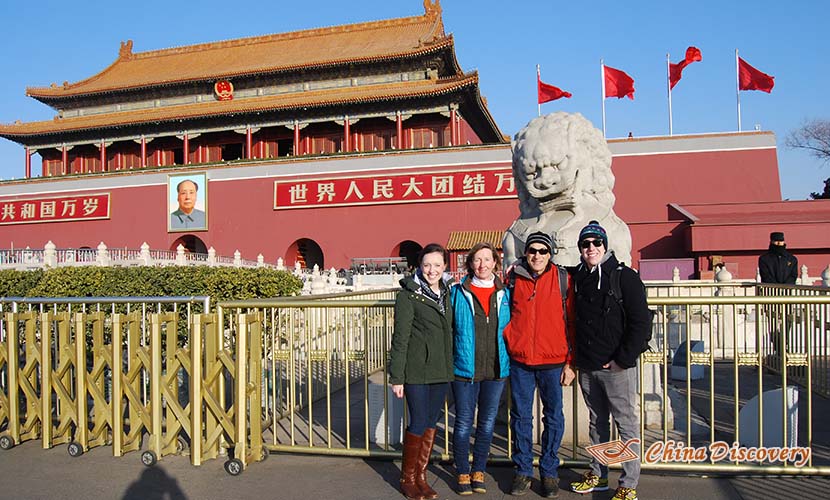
[{"xmin": 0, "ymin": 193, "xmax": 110, "ymax": 224}]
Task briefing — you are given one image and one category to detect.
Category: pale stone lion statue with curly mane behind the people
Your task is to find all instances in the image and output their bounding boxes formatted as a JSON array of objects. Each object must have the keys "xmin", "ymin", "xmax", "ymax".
[{"xmin": 503, "ymin": 112, "xmax": 631, "ymax": 266}]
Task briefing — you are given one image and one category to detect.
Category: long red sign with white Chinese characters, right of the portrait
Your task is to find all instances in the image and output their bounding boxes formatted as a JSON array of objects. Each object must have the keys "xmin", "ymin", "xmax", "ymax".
[{"xmin": 274, "ymin": 167, "xmax": 516, "ymax": 210}]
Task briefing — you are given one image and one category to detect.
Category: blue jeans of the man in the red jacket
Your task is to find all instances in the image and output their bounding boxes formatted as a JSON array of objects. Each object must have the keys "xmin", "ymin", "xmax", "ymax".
[{"xmin": 510, "ymin": 361, "xmax": 565, "ymax": 477}]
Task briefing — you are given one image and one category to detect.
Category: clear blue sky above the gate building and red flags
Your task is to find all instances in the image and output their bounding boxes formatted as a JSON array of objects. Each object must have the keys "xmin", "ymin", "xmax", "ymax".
[{"xmin": 0, "ymin": 0, "xmax": 830, "ymax": 199}]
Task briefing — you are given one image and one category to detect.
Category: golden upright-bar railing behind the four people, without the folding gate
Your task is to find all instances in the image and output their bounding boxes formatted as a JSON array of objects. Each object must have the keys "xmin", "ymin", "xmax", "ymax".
[{"xmin": 220, "ymin": 292, "xmax": 830, "ymax": 474}]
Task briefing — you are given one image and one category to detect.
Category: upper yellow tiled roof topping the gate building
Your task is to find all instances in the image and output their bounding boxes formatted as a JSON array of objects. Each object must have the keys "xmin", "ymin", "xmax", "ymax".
[{"xmin": 26, "ymin": 0, "xmax": 453, "ymax": 98}]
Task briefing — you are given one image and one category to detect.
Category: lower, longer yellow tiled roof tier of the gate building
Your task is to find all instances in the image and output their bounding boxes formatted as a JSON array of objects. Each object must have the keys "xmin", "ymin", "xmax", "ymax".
[{"xmin": 0, "ymin": 73, "xmax": 478, "ymax": 137}]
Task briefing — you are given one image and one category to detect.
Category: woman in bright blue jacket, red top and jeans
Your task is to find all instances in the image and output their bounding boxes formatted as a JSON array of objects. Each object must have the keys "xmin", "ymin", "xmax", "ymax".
[{"xmin": 450, "ymin": 243, "xmax": 510, "ymax": 495}]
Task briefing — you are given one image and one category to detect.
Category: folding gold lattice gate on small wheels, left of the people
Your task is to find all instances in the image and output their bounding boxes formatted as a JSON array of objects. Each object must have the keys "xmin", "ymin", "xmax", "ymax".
[{"xmin": 0, "ymin": 297, "xmax": 265, "ymax": 475}]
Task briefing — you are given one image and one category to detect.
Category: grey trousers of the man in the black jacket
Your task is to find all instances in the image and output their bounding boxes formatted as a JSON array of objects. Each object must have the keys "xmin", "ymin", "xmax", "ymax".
[{"xmin": 579, "ymin": 367, "xmax": 640, "ymax": 488}]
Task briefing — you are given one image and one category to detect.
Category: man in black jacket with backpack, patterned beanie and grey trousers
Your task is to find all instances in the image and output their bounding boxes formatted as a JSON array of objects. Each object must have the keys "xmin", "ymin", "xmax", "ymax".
[{"xmin": 571, "ymin": 221, "xmax": 651, "ymax": 500}]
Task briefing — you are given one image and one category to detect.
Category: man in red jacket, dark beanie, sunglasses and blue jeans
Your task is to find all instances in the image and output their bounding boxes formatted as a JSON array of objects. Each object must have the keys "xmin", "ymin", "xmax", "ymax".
[{"xmin": 504, "ymin": 232, "xmax": 575, "ymax": 498}]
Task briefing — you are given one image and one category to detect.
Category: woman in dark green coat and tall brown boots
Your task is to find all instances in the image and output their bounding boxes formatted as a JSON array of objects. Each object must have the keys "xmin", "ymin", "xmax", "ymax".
[{"xmin": 389, "ymin": 243, "xmax": 453, "ymax": 500}]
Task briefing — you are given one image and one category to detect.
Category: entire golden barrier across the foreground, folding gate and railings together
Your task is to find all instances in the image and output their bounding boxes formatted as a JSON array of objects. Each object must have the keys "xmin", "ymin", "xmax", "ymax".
[{"xmin": 0, "ymin": 288, "xmax": 830, "ymax": 475}]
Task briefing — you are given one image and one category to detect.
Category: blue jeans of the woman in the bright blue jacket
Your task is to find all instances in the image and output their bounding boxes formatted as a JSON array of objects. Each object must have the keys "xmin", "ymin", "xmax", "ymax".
[{"xmin": 452, "ymin": 379, "xmax": 505, "ymax": 474}]
